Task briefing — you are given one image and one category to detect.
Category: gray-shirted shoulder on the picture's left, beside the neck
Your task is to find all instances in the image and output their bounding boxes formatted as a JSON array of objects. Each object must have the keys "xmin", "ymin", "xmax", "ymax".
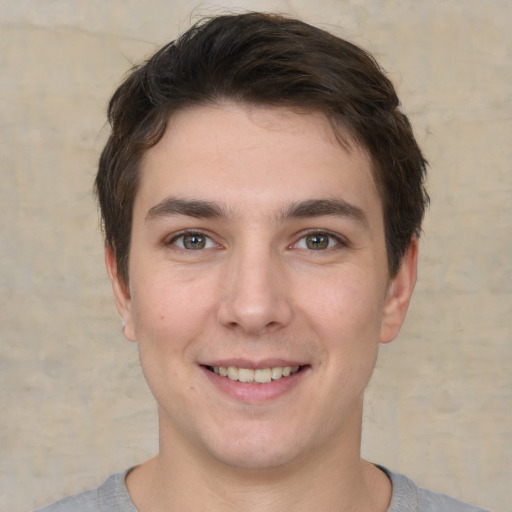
[{"xmin": 35, "ymin": 471, "xmax": 137, "ymax": 512}]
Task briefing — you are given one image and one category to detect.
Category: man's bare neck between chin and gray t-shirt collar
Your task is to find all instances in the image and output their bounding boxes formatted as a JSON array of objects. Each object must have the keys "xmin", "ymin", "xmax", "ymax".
[{"xmin": 127, "ymin": 404, "xmax": 391, "ymax": 512}]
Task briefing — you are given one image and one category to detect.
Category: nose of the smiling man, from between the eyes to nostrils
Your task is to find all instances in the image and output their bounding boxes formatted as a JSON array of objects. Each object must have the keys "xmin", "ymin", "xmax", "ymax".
[{"xmin": 218, "ymin": 247, "xmax": 293, "ymax": 336}]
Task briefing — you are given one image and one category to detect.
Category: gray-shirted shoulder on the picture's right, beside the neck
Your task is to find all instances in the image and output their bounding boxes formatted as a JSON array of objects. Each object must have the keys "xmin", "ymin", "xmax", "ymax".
[{"xmin": 379, "ymin": 466, "xmax": 488, "ymax": 512}]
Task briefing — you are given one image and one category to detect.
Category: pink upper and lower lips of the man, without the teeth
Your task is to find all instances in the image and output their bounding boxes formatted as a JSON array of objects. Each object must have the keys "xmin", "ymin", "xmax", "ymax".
[{"xmin": 200, "ymin": 359, "xmax": 311, "ymax": 405}]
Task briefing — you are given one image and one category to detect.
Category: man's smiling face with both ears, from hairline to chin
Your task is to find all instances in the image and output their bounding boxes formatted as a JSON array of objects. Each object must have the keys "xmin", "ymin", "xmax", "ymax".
[{"xmin": 107, "ymin": 104, "xmax": 416, "ymax": 469}]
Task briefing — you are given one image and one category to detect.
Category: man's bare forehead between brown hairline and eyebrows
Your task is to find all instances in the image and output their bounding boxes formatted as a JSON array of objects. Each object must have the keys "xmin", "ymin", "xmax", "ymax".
[{"xmin": 135, "ymin": 103, "xmax": 380, "ymax": 222}]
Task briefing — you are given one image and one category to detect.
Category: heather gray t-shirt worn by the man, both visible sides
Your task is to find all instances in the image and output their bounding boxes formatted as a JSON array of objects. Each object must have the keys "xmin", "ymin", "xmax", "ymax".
[{"xmin": 35, "ymin": 466, "xmax": 489, "ymax": 512}]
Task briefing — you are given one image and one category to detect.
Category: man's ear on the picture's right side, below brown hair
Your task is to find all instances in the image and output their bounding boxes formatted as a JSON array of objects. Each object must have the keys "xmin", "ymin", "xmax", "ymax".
[{"xmin": 380, "ymin": 237, "xmax": 418, "ymax": 343}]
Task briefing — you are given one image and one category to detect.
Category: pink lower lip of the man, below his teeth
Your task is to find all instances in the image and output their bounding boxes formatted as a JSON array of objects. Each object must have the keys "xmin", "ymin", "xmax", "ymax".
[{"xmin": 202, "ymin": 367, "xmax": 308, "ymax": 403}]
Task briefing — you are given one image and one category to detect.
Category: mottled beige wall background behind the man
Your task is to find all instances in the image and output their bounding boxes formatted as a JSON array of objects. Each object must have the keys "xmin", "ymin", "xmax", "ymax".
[{"xmin": 0, "ymin": 0, "xmax": 512, "ymax": 512}]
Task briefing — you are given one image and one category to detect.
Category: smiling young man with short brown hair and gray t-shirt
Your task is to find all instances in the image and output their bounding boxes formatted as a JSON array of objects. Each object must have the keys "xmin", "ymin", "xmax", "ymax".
[{"xmin": 37, "ymin": 13, "xmax": 488, "ymax": 512}]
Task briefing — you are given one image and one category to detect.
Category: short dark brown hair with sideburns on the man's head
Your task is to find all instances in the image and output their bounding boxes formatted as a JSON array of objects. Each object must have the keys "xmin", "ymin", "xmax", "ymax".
[{"xmin": 95, "ymin": 13, "xmax": 428, "ymax": 283}]
